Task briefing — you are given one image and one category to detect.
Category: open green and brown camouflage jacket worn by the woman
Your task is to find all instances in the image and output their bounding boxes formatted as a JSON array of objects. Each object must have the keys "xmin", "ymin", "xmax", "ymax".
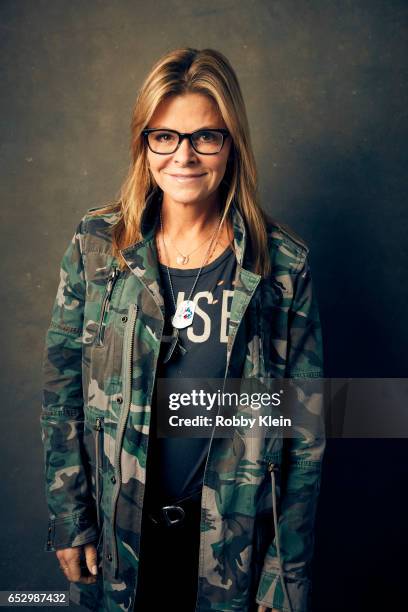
[{"xmin": 41, "ymin": 189, "xmax": 325, "ymax": 612}]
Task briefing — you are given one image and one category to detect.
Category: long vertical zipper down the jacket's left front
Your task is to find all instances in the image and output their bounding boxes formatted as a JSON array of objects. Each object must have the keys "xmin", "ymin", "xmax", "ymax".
[{"xmin": 111, "ymin": 304, "xmax": 139, "ymax": 575}]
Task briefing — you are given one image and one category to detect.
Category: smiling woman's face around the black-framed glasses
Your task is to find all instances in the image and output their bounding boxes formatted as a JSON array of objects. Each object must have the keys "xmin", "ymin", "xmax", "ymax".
[{"xmin": 147, "ymin": 93, "xmax": 231, "ymax": 204}]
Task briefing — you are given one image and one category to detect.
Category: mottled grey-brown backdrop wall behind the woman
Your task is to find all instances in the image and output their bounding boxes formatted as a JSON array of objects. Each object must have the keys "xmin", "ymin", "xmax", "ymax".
[{"xmin": 0, "ymin": 0, "xmax": 408, "ymax": 612}]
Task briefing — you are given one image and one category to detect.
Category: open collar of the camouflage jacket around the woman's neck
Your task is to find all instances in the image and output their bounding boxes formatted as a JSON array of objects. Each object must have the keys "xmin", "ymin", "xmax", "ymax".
[{"xmin": 120, "ymin": 189, "xmax": 261, "ymax": 322}]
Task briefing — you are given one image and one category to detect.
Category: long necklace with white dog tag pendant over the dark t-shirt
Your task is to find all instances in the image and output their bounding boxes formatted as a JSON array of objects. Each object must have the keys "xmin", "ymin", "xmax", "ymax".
[{"xmin": 160, "ymin": 208, "xmax": 221, "ymax": 363}]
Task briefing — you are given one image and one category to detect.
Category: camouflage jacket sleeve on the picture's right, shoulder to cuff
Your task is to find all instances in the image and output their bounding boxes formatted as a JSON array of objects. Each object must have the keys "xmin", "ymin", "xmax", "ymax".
[{"xmin": 256, "ymin": 252, "xmax": 325, "ymax": 612}]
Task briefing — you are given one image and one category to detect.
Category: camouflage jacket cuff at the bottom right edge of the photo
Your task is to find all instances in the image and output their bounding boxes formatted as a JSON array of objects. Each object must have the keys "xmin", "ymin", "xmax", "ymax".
[{"xmin": 256, "ymin": 571, "xmax": 311, "ymax": 612}]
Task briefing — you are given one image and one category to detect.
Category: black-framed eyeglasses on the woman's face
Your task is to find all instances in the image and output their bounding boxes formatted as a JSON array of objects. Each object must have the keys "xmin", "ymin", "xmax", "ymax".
[{"xmin": 142, "ymin": 128, "xmax": 229, "ymax": 155}]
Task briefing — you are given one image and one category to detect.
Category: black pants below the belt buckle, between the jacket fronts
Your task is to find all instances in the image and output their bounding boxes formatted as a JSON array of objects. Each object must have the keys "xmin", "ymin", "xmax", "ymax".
[{"xmin": 134, "ymin": 502, "xmax": 201, "ymax": 612}]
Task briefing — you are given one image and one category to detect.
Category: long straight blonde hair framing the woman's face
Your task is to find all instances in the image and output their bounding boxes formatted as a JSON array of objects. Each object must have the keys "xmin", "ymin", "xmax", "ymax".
[{"xmin": 91, "ymin": 48, "xmax": 270, "ymax": 276}]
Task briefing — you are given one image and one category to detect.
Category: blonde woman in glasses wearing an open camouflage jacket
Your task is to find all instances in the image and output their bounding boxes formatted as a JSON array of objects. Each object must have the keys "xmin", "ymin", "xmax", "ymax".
[{"xmin": 41, "ymin": 49, "xmax": 325, "ymax": 612}]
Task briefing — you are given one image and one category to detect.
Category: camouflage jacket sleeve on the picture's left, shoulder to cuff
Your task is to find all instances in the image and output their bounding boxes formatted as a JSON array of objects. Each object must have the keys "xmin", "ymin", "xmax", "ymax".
[{"xmin": 40, "ymin": 220, "xmax": 97, "ymax": 551}]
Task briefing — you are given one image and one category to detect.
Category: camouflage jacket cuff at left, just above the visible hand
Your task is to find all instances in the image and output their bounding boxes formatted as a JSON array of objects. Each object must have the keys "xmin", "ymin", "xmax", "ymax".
[{"xmin": 44, "ymin": 512, "xmax": 98, "ymax": 552}]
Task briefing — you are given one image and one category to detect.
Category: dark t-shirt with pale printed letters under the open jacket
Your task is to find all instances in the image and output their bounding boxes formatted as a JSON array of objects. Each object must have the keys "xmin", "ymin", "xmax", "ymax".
[{"xmin": 146, "ymin": 247, "xmax": 236, "ymax": 504}]
